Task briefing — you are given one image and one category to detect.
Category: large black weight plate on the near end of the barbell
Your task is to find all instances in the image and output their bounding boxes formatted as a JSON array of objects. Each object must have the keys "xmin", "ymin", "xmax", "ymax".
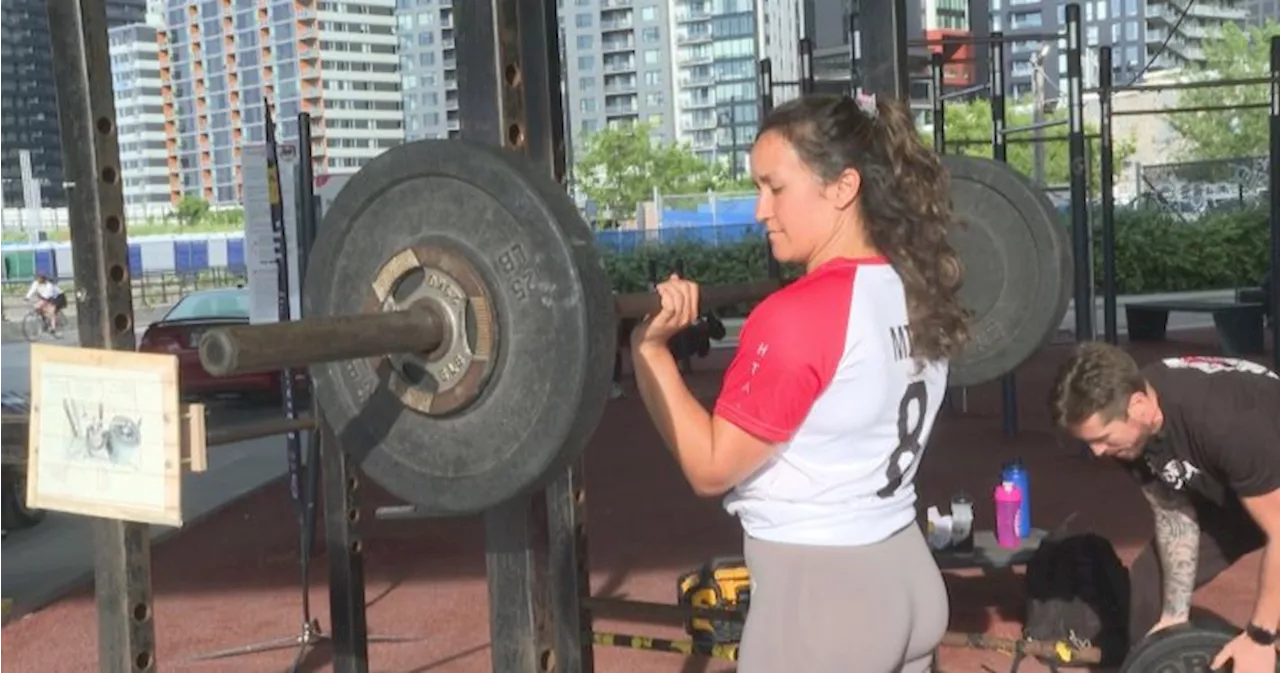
[{"xmin": 303, "ymin": 139, "xmax": 616, "ymax": 516}]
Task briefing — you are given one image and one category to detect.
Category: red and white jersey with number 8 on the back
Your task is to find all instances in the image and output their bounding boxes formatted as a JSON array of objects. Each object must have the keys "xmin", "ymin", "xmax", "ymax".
[{"xmin": 716, "ymin": 257, "xmax": 947, "ymax": 545}]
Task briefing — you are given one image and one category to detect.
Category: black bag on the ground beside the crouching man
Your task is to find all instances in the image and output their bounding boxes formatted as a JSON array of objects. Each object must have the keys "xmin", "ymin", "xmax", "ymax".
[{"xmin": 1014, "ymin": 525, "xmax": 1129, "ymax": 670}]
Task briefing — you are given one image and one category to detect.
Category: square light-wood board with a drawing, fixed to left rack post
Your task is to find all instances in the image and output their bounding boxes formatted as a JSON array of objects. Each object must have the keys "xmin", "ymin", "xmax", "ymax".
[{"xmin": 27, "ymin": 344, "xmax": 184, "ymax": 526}]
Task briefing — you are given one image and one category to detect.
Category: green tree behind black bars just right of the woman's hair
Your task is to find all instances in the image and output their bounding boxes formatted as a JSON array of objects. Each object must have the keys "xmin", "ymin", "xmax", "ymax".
[{"xmin": 920, "ymin": 99, "xmax": 1135, "ymax": 194}]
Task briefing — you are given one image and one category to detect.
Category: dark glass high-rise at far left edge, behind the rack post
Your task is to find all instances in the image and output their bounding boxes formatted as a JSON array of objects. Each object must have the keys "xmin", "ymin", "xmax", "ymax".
[{"xmin": 0, "ymin": 0, "xmax": 146, "ymax": 207}]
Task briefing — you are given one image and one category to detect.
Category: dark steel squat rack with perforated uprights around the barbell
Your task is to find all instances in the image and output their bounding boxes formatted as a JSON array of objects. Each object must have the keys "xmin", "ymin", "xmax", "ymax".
[{"xmin": 47, "ymin": 0, "xmax": 1100, "ymax": 673}]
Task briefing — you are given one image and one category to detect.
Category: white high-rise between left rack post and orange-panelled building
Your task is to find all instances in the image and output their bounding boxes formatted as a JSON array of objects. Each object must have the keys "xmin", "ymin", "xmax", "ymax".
[{"xmin": 108, "ymin": 23, "xmax": 170, "ymax": 218}]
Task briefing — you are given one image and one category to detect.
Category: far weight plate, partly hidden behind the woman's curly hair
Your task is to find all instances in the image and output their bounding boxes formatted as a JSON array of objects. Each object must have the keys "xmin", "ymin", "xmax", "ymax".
[{"xmin": 942, "ymin": 155, "xmax": 1071, "ymax": 386}]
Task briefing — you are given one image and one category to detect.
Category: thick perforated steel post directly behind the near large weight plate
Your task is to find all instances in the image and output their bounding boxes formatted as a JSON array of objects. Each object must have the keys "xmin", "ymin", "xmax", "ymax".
[{"xmin": 453, "ymin": 0, "xmax": 565, "ymax": 673}]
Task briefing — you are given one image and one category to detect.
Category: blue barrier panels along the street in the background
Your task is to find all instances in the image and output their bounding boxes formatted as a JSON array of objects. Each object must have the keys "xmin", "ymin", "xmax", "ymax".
[{"xmin": 0, "ymin": 223, "xmax": 764, "ymax": 281}]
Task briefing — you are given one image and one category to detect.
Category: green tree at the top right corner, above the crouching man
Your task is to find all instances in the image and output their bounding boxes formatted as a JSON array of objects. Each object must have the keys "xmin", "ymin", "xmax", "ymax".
[{"xmin": 1167, "ymin": 20, "xmax": 1280, "ymax": 161}]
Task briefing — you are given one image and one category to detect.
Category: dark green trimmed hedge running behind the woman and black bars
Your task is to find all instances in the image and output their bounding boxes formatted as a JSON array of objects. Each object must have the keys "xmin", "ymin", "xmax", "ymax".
[{"xmin": 603, "ymin": 205, "xmax": 1270, "ymax": 313}]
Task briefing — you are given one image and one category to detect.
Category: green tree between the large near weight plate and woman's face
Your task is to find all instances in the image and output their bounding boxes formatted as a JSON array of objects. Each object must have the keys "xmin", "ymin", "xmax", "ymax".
[{"xmin": 575, "ymin": 123, "xmax": 733, "ymax": 226}]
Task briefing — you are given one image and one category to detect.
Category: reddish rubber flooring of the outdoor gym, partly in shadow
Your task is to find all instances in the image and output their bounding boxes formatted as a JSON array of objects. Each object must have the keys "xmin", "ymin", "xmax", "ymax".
[{"xmin": 0, "ymin": 331, "xmax": 1257, "ymax": 673}]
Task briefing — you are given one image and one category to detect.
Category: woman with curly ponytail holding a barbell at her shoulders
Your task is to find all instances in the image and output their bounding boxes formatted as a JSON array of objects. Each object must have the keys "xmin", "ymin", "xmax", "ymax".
[{"xmin": 631, "ymin": 95, "xmax": 968, "ymax": 673}]
